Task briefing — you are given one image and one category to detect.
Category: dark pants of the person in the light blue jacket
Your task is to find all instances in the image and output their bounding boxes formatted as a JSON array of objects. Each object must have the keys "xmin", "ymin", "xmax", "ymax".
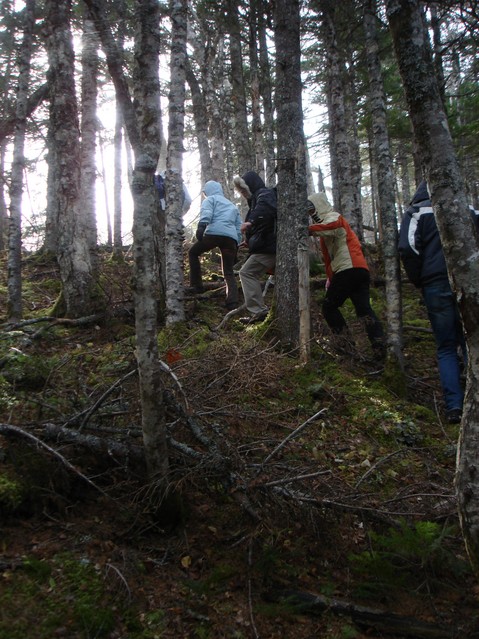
[{"xmin": 188, "ymin": 234, "xmax": 238, "ymax": 308}]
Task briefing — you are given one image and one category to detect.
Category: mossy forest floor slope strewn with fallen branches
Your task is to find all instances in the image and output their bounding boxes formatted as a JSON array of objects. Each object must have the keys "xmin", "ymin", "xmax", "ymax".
[{"xmin": 0, "ymin": 246, "xmax": 479, "ymax": 639}]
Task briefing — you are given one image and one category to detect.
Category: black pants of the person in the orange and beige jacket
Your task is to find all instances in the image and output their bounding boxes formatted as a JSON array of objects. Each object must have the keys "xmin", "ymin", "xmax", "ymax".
[{"xmin": 322, "ymin": 268, "xmax": 384, "ymax": 348}]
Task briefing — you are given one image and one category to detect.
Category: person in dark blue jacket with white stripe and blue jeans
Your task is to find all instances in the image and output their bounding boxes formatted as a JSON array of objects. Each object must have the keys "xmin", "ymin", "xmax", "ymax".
[{"xmin": 399, "ymin": 180, "xmax": 479, "ymax": 423}]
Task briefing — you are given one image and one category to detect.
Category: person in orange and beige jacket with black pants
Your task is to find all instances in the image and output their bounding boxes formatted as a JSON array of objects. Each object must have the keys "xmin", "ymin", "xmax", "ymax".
[{"xmin": 308, "ymin": 192, "xmax": 386, "ymax": 360}]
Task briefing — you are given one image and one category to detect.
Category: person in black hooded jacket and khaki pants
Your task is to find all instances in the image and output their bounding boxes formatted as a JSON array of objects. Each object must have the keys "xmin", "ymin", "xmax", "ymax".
[{"xmin": 234, "ymin": 171, "xmax": 277, "ymax": 324}]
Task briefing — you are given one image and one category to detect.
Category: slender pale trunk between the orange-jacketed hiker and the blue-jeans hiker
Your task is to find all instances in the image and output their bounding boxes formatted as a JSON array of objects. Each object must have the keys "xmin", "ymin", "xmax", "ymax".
[{"xmin": 363, "ymin": 0, "xmax": 404, "ymax": 370}]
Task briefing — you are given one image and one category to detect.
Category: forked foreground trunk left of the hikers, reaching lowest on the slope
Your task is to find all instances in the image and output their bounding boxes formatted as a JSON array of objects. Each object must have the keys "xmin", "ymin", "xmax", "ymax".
[{"xmin": 85, "ymin": 0, "xmax": 169, "ymax": 488}]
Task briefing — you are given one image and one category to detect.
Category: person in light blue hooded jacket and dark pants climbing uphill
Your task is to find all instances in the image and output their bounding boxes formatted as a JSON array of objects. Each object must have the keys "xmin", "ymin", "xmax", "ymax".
[{"xmin": 188, "ymin": 180, "xmax": 242, "ymax": 310}]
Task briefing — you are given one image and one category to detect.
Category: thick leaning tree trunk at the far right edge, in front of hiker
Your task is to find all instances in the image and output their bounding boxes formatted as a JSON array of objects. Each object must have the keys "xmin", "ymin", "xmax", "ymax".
[{"xmin": 386, "ymin": 0, "xmax": 479, "ymax": 575}]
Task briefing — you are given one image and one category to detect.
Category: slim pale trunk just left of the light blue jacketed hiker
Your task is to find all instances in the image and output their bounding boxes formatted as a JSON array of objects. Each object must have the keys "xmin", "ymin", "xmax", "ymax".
[{"xmin": 166, "ymin": 0, "xmax": 188, "ymax": 324}]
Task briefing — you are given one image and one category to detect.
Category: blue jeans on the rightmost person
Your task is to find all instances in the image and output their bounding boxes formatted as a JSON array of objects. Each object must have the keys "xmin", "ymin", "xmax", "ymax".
[{"xmin": 422, "ymin": 280, "xmax": 467, "ymax": 411}]
